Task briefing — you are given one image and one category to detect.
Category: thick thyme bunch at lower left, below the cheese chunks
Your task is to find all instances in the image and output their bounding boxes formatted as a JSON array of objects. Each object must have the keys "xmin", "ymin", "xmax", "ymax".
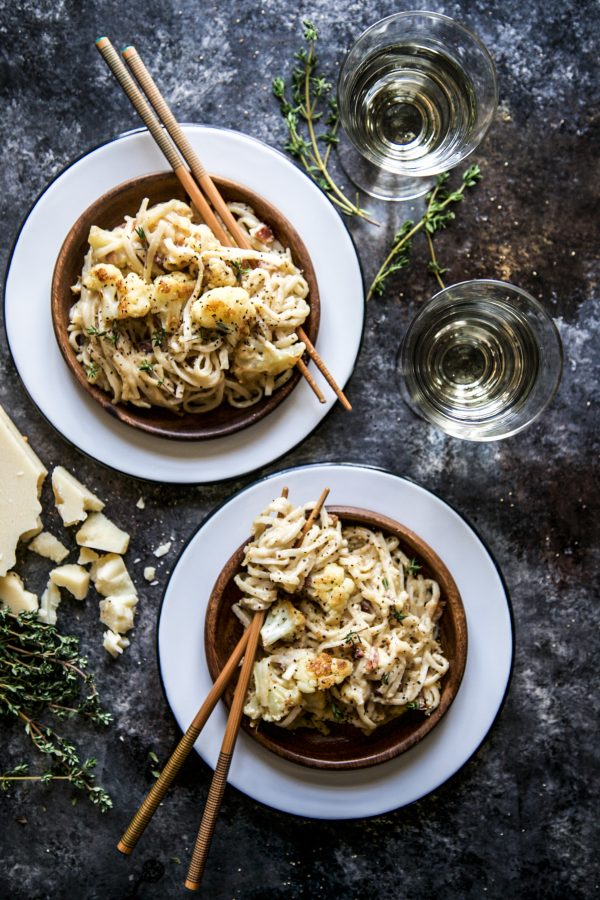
[{"xmin": 0, "ymin": 609, "xmax": 112, "ymax": 812}]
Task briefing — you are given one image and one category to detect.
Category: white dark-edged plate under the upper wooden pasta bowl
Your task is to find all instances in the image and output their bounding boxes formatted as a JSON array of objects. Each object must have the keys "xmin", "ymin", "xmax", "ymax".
[{"xmin": 4, "ymin": 125, "xmax": 364, "ymax": 484}]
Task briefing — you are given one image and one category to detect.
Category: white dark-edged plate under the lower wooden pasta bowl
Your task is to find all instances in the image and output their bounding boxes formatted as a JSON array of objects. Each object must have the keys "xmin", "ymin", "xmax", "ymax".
[{"xmin": 158, "ymin": 464, "xmax": 513, "ymax": 819}]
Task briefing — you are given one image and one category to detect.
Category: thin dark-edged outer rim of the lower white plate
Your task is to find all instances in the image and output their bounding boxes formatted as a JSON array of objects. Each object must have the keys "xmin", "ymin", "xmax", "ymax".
[{"xmin": 154, "ymin": 460, "xmax": 516, "ymax": 822}]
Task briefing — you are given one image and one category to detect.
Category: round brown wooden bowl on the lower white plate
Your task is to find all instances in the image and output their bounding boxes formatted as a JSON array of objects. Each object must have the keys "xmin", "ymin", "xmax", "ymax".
[{"xmin": 204, "ymin": 506, "xmax": 467, "ymax": 769}]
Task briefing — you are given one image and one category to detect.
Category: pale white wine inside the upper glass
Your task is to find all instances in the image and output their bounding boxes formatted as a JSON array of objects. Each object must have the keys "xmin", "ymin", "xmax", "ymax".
[{"xmin": 344, "ymin": 40, "xmax": 478, "ymax": 176}]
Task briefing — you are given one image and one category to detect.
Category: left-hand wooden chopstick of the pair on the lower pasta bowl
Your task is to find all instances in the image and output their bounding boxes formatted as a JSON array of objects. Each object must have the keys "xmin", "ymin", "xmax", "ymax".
[{"xmin": 117, "ymin": 629, "xmax": 250, "ymax": 855}]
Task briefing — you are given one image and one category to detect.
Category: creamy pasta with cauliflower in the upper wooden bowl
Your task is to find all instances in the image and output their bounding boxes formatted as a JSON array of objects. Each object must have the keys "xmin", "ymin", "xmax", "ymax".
[{"xmin": 69, "ymin": 199, "xmax": 310, "ymax": 413}]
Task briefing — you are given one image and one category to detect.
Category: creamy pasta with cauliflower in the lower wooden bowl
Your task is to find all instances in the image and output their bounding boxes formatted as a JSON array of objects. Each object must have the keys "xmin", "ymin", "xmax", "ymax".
[{"xmin": 233, "ymin": 497, "xmax": 449, "ymax": 734}]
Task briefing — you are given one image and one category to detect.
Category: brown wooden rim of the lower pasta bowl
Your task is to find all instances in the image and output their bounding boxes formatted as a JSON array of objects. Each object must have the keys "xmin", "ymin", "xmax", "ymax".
[{"xmin": 204, "ymin": 504, "xmax": 468, "ymax": 771}]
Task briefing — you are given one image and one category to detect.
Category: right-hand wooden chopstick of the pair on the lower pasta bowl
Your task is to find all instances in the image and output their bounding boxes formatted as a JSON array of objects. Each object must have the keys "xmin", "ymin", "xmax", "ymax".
[{"xmin": 185, "ymin": 488, "xmax": 329, "ymax": 891}]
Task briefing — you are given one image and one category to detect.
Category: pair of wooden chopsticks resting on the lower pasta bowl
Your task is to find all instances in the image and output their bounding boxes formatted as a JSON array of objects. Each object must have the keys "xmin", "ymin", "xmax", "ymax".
[{"xmin": 117, "ymin": 488, "xmax": 329, "ymax": 890}]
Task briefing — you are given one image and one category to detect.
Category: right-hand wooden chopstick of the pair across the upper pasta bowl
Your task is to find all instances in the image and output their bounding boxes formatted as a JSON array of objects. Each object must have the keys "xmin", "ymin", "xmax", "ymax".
[{"xmin": 123, "ymin": 45, "xmax": 352, "ymax": 411}]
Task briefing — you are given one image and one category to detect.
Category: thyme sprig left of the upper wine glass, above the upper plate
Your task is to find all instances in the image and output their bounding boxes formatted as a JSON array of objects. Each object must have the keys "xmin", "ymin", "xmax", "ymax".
[{"xmin": 272, "ymin": 20, "xmax": 379, "ymax": 225}]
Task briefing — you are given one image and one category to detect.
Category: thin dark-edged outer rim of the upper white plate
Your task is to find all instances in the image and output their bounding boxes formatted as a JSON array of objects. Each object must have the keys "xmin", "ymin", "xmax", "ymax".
[{"xmin": 1, "ymin": 122, "xmax": 367, "ymax": 486}]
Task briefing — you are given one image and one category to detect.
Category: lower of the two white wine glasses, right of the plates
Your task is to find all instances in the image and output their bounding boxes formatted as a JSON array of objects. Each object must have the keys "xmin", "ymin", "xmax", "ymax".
[{"xmin": 397, "ymin": 279, "xmax": 563, "ymax": 441}]
